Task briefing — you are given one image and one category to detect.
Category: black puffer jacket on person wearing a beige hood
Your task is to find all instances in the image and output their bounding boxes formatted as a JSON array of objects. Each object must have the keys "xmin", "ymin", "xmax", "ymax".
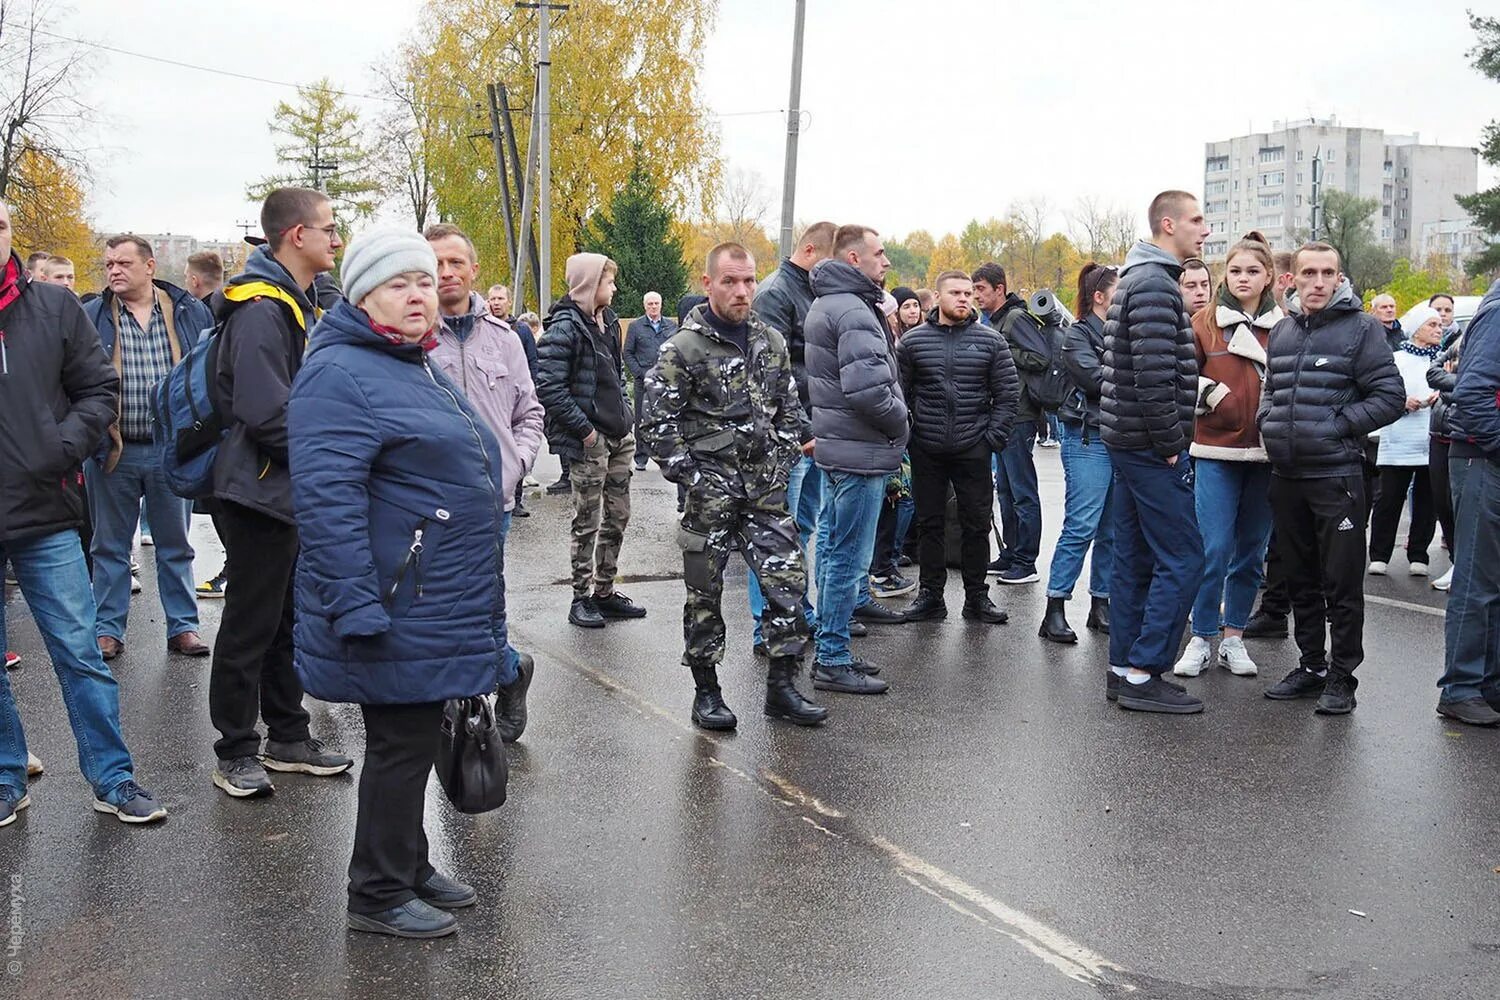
[{"xmin": 536, "ymin": 295, "xmax": 629, "ymax": 462}]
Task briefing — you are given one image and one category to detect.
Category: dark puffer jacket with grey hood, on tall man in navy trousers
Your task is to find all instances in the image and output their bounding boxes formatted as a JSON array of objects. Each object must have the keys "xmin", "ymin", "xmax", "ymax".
[{"xmin": 1100, "ymin": 241, "xmax": 1199, "ymax": 459}]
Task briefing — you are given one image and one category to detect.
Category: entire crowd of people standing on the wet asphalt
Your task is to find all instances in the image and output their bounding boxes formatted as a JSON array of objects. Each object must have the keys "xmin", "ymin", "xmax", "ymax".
[{"xmin": 0, "ymin": 187, "xmax": 1500, "ymax": 937}]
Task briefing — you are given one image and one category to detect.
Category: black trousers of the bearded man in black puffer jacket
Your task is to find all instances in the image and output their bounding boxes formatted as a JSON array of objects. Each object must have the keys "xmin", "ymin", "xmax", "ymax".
[{"xmin": 908, "ymin": 441, "xmax": 992, "ymax": 600}]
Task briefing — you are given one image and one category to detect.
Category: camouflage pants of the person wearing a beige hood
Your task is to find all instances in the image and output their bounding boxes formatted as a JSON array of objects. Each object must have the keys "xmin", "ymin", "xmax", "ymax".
[{"xmin": 569, "ymin": 433, "xmax": 636, "ymax": 598}]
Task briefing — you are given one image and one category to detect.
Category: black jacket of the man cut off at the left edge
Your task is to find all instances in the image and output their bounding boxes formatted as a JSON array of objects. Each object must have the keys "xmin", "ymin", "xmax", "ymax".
[{"xmin": 0, "ymin": 253, "xmax": 120, "ymax": 541}]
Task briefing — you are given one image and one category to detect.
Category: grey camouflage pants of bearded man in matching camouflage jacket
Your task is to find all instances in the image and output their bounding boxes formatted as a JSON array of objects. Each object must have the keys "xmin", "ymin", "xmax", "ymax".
[{"xmin": 678, "ymin": 489, "xmax": 809, "ymax": 667}]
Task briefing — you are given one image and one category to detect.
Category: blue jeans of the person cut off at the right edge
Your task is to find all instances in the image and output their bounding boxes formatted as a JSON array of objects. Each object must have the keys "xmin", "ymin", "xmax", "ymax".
[{"xmin": 1437, "ymin": 459, "xmax": 1500, "ymax": 703}]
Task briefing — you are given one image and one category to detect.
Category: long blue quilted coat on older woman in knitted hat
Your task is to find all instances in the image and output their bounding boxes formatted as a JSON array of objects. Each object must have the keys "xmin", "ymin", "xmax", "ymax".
[{"xmin": 288, "ymin": 303, "xmax": 504, "ymax": 705}]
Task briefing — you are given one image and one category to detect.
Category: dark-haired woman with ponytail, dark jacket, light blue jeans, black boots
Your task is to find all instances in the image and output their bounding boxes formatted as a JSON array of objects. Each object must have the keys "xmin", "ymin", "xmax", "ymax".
[{"xmin": 1038, "ymin": 261, "xmax": 1119, "ymax": 643}]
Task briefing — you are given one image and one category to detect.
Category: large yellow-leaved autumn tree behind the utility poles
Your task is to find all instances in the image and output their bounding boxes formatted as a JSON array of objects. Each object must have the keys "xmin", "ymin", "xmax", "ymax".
[{"xmin": 413, "ymin": 0, "xmax": 720, "ymax": 307}]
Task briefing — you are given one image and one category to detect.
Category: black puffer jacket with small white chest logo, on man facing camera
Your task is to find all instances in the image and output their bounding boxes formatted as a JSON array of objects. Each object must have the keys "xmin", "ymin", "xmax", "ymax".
[{"xmin": 1256, "ymin": 279, "xmax": 1406, "ymax": 480}]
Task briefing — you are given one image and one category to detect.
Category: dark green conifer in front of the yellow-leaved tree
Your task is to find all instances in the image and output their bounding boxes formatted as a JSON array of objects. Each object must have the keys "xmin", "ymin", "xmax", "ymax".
[{"xmin": 579, "ymin": 160, "xmax": 687, "ymax": 316}]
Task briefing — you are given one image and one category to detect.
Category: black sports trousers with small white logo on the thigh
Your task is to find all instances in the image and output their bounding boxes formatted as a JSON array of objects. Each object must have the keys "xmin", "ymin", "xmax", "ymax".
[{"xmin": 1271, "ymin": 472, "xmax": 1368, "ymax": 684}]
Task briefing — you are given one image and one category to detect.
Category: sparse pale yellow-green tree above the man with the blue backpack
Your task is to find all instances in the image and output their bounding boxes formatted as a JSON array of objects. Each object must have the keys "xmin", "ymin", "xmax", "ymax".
[{"xmin": 245, "ymin": 76, "xmax": 381, "ymax": 217}]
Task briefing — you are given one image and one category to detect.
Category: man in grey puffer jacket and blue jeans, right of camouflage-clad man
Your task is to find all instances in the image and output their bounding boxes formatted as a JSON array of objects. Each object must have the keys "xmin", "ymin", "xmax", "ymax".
[{"xmin": 806, "ymin": 225, "xmax": 909, "ymax": 694}]
